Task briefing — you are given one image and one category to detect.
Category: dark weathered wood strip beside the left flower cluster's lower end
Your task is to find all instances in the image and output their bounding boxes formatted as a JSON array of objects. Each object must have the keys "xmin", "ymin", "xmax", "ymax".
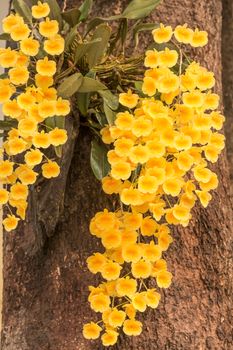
[{"xmin": 21, "ymin": 115, "xmax": 79, "ymax": 255}]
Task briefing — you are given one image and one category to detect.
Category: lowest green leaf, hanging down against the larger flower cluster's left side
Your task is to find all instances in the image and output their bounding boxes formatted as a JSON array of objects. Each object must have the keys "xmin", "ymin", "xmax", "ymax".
[{"xmin": 90, "ymin": 140, "xmax": 110, "ymax": 180}]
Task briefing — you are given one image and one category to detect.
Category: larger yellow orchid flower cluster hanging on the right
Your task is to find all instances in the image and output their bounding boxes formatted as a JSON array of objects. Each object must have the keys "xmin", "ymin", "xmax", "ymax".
[{"xmin": 83, "ymin": 24, "xmax": 224, "ymax": 346}]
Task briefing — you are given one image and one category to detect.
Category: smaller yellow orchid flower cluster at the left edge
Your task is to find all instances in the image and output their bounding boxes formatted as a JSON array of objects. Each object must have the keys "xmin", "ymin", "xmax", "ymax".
[{"xmin": 0, "ymin": 2, "xmax": 70, "ymax": 231}]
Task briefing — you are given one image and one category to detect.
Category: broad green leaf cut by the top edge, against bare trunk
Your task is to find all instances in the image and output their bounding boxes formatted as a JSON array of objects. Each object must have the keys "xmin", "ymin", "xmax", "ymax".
[{"xmin": 122, "ymin": 0, "xmax": 160, "ymax": 19}]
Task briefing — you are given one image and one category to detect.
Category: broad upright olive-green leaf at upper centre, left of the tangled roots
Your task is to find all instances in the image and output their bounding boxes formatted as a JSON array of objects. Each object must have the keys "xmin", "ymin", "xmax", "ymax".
[{"xmin": 87, "ymin": 23, "xmax": 111, "ymax": 69}]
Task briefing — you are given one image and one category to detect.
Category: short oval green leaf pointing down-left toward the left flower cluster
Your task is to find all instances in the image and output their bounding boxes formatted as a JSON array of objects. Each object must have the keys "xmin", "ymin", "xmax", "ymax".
[{"xmin": 57, "ymin": 73, "xmax": 83, "ymax": 98}]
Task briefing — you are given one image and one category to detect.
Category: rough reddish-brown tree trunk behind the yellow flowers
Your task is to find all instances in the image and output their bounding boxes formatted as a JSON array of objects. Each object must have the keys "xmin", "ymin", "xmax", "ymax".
[{"xmin": 2, "ymin": 0, "xmax": 233, "ymax": 350}]
